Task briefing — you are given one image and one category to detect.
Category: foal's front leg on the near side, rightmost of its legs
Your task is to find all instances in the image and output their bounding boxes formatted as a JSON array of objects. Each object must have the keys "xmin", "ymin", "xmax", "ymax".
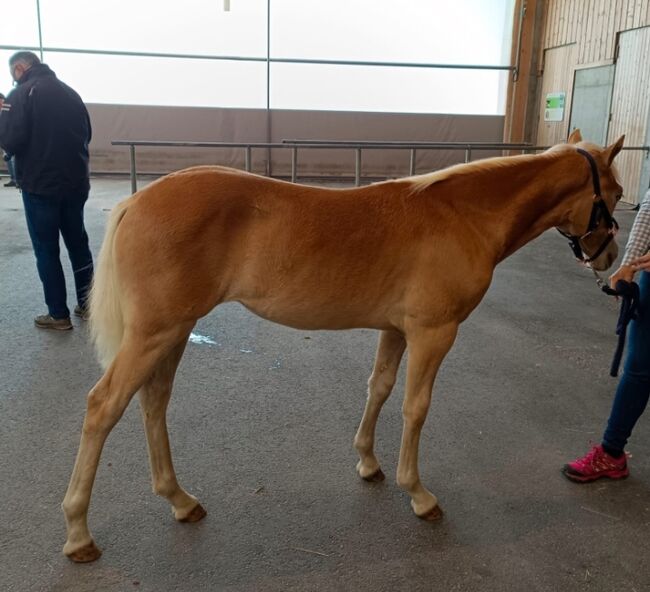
[{"xmin": 397, "ymin": 323, "xmax": 458, "ymax": 520}]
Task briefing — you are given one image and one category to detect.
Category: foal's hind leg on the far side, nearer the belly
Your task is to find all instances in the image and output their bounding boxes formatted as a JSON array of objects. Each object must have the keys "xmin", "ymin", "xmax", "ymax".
[{"xmin": 139, "ymin": 339, "xmax": 205, "ymax": 522}]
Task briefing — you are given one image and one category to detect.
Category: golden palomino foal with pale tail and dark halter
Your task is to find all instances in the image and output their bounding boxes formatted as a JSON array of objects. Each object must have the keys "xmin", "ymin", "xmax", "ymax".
[{"xmin": 63, "ymin": 133, "xmax": 623, "ymax": 561}]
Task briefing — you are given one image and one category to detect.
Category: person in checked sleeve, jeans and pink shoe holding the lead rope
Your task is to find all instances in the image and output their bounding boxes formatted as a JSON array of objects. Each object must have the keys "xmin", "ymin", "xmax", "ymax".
[{"xmin": 562, "ymin": 189, "xmax": 650, "ymax": 483}]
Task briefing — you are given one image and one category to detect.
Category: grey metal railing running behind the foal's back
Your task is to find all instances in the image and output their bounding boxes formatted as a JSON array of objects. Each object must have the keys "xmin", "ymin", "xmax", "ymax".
[{"xmin": 111, "ymin": 140, "xmax": 650, "ymax": 193}]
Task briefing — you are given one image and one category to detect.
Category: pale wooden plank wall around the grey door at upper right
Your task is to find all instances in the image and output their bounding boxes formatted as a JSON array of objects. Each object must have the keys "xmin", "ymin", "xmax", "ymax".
[{"xmin": 537, "ymin": 0, "xmax": 650, "ymax": 203}]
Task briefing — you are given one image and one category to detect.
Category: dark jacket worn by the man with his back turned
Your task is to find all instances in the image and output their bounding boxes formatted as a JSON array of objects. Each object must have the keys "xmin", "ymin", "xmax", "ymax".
[{"xmin": 0, "ymin": 64, "xmax": 92, "ymax": 196}]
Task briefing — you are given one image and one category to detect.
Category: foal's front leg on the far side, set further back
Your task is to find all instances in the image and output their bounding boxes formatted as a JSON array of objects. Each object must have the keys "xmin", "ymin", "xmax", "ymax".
[{"xmin": 354, "ymin": 331, "xmax": 406, "ymax": 481}]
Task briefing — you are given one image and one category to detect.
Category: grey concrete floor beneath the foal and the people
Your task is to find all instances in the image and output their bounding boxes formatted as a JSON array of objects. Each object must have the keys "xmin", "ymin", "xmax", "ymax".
[{"xmin": 0, "ymin": 179, "xmax": 650, "ymax": 592}]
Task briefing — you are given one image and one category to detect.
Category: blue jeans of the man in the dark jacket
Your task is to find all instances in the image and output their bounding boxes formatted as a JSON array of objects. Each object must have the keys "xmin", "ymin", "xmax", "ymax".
[{"xmin": 23, "ymin": 191, "xmax": 93, "ymax": 319}]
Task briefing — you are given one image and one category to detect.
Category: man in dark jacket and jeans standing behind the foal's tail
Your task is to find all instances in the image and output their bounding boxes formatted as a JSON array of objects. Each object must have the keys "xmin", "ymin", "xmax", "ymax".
[{"xmin": 0, "ymin": 51, "xmax": 93, "ymax": 330}]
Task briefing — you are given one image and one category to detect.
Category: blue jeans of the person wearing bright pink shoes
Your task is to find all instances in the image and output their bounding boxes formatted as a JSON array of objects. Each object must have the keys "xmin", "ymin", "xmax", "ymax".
[{"xmin": 603, "ymin": 271, "xmax": 650, "ymax": 453}]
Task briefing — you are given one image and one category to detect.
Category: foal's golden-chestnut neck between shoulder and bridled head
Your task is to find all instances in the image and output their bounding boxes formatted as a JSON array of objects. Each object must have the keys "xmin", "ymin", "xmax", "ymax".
[{"xmin": 466, "ymin": 155, "xmax": 588, "ymax": 262}]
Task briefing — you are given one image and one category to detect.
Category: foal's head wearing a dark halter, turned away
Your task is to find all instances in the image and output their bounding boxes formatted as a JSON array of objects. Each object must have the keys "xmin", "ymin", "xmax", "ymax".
[{"xmin": 558, "ymin": 130, "xmax": 625, "ymax": 271}]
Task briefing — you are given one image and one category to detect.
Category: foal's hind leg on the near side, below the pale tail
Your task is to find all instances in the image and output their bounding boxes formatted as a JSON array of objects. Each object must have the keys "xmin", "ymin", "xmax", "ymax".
[{"xmin": 62, "ymin": 327, "xmax": 190, "ymax": 562}]
